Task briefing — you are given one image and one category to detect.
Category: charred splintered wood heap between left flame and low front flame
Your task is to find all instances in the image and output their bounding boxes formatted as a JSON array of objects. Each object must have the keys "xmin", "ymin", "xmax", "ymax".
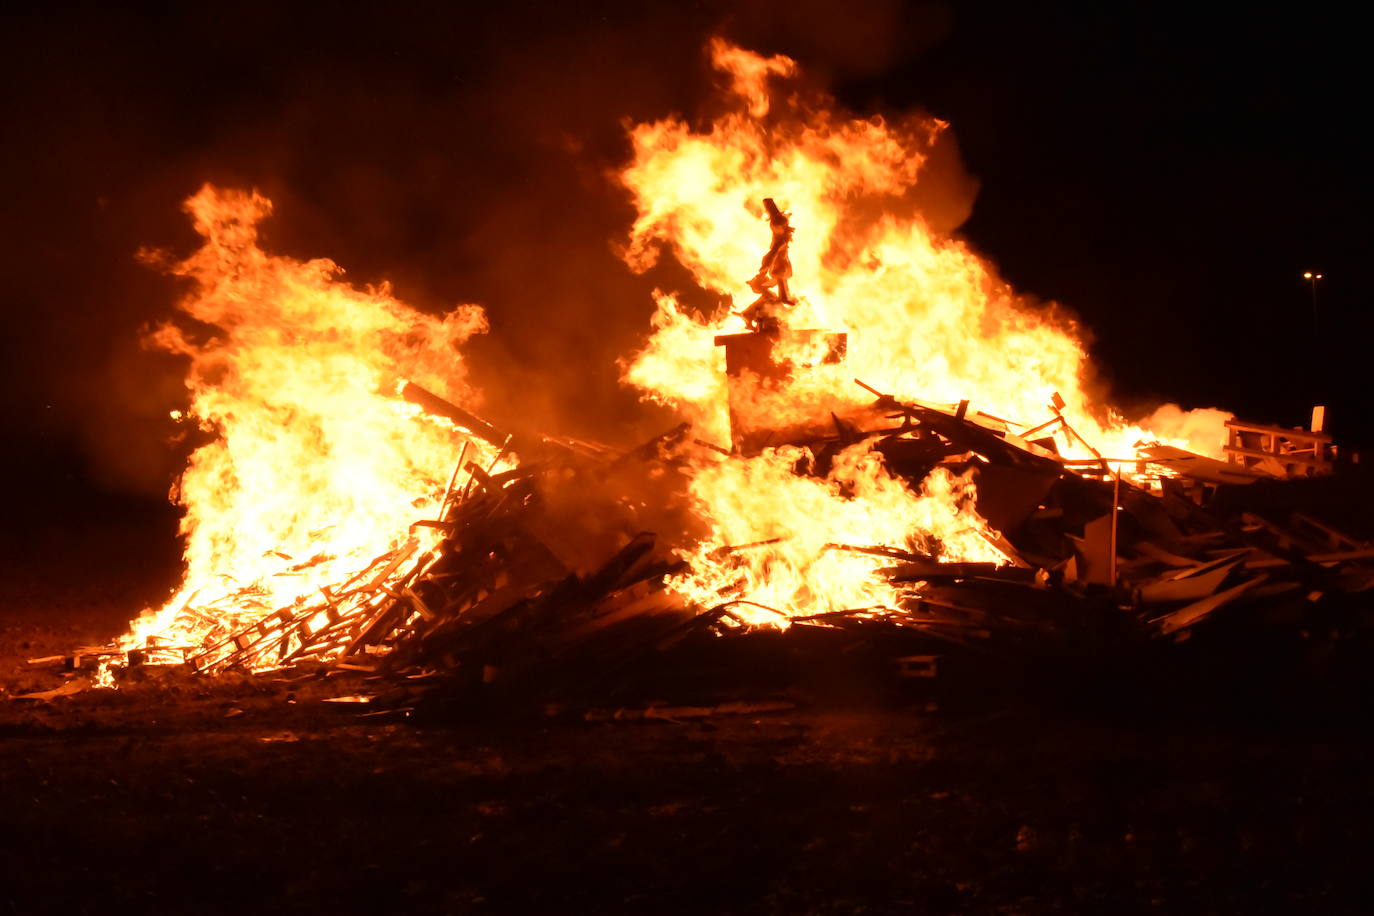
[{"xmin": 109, "ymin": 385, "xmax": 695, "ymax": 694}]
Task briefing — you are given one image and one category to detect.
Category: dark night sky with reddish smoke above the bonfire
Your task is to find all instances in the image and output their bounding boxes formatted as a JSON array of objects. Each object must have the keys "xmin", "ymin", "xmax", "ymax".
[{"xmin": 0, "ymin": 1, "xmax": 1374, "ymax": 516}]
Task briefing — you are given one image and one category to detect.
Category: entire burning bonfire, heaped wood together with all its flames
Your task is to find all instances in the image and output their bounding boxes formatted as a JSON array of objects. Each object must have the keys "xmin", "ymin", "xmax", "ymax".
[{"xmin": 24, "ymin": 43, "xmax": 1374, "ymax": 696}]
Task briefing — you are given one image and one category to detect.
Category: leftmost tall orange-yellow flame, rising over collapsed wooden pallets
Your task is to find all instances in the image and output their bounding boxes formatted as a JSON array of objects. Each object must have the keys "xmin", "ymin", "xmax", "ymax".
[{"xmin": 125, "ymin": 185, "xmax": 491, "ymax": 659}]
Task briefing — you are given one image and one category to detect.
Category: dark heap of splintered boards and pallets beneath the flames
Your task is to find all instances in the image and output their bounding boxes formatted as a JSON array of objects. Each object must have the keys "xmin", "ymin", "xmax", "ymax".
[{"xmin": 85, "ymin": 382, "xmax": 1374, "ymax": 692}]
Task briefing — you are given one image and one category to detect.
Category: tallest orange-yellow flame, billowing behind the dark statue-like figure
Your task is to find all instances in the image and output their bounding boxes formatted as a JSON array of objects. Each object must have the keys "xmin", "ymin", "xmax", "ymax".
[{"xmin": 621, "ymin": 38, "xmax": 1228, "ymax": 457}]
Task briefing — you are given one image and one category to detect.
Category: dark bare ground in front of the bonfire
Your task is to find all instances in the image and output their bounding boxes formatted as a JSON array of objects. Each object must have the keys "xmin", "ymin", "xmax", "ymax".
[{"xmin": 0, "ymin": 513, "xmax": 1374, "ymax": 913}]
